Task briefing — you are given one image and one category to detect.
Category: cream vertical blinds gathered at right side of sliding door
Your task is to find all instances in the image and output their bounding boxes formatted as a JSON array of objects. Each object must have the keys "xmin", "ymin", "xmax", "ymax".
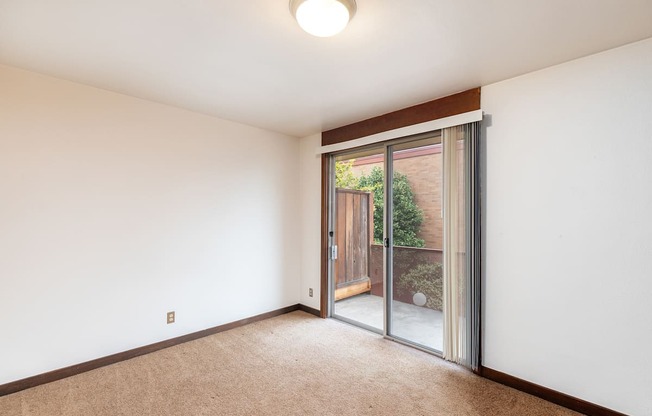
[{"xmin": 442, "ymin": 122, "xmax": 480, "ymax": 371}]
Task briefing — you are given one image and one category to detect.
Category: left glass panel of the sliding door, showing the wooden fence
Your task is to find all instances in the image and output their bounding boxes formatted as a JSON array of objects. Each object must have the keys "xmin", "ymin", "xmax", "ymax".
[{"xmin": 330, "ymin": 147, "xmax": 385, "ymax": 333}]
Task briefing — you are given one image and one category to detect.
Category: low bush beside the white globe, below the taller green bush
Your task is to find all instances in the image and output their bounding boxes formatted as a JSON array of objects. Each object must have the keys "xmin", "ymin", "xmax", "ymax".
[{"xmin": 397, "ymin": 263, "xmax": 444, "ymax": 311}]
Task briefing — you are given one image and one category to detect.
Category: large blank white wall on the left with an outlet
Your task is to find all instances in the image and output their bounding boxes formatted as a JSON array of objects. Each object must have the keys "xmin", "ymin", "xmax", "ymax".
[{"xmin": 0, "ymin": 66, "xmax": 300, "ymax": 384}]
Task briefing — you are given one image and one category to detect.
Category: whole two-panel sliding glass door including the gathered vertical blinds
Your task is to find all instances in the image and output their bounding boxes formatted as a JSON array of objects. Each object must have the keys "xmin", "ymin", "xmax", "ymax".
[{"xmin": 328, "ymin": 124, "xmax": 480, "ymax": 368}]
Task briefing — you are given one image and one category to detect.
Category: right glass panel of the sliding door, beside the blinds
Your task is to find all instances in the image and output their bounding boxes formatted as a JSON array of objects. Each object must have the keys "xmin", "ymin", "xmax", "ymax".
[{"xmin": 386, "ymin": 135, "xmax": 444, "ymax": 352}]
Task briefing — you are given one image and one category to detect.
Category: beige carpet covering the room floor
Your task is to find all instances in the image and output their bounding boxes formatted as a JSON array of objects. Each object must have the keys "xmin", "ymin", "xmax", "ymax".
[{"xmin": 0, "ymin": 312, "xmax": 576, "ymax": 416}]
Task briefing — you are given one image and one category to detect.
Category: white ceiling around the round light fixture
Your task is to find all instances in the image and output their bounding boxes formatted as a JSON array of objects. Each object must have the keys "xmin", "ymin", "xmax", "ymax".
[{"xmin": 0, "ymin": 0, "xmax": 652, "ymax": 137}]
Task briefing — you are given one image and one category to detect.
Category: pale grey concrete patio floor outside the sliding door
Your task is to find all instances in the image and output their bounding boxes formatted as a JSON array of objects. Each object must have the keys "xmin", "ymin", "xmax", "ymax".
[{"xmin": 333, "ymin": 294, "xmax": 444, "ymax": 352}]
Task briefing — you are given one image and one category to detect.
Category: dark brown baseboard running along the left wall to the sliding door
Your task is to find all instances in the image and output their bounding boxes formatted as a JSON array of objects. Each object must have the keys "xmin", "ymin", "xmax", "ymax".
[{"xmin": 0, "ymin": 304, "xmax": 300, "ymax": 397}]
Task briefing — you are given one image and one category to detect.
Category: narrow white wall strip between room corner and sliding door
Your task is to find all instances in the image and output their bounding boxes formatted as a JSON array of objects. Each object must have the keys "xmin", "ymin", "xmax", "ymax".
[{"xmin": 301, "ymin": 134, "xmax": 321, "ymax": 309}]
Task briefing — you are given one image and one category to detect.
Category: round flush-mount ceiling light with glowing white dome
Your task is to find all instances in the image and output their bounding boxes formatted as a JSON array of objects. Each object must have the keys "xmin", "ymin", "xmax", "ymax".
[{"xmin": 290, "ymin": 0, "xmax": 356, "ymax": 38}]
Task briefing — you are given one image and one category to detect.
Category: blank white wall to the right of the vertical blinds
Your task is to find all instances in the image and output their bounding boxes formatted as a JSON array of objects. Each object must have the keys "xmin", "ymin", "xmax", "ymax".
[{"xmin": 482, "ymin": 39, "xmax": 652, "ymax": 415}]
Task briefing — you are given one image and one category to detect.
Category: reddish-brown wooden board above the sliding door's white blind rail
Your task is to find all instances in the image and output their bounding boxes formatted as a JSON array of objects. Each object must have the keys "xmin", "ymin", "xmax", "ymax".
[{"xmin": 321, "ymin": 88, "xmax": 480, "ymax": 146}]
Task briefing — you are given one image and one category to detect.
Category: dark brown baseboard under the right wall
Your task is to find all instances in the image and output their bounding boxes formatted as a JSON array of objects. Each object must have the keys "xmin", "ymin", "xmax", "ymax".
[{"xmin": 479, "ymin": 367, "xmax": 626, "ymax": 416}]
